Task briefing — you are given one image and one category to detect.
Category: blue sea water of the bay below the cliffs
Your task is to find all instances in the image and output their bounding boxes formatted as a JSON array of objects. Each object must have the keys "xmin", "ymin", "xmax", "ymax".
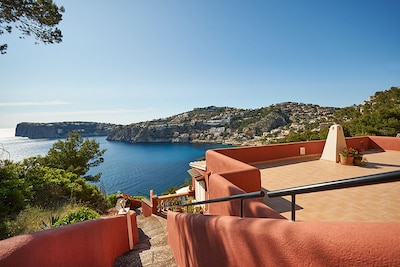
[{"xmin": 0, "ymin": 128, "xmax": 227, "ymax": 196}]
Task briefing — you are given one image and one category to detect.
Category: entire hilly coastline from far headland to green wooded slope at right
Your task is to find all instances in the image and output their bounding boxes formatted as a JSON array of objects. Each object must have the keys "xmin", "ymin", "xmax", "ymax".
[{"xmin": 16, "ymin": 87, "xmax": 400, "ymax": 145}]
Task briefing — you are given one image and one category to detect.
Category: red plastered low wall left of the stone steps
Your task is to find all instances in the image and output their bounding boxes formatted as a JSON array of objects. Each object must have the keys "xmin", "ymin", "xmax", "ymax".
[{"xmin": 0, "ymin": 211, "xmax": 139, "ymax": 267}]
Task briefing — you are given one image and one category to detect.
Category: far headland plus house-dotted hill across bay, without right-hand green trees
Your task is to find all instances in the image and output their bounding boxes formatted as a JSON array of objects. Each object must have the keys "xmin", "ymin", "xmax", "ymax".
[{"xmin": 16, "ymin": 102, "xmax": 335, "ymax": 145}]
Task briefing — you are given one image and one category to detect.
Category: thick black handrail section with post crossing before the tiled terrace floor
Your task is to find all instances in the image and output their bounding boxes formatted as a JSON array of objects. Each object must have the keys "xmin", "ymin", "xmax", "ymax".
[{"xmin": 267, "ymin": 171, "xmax": 400, "ymax": 221}]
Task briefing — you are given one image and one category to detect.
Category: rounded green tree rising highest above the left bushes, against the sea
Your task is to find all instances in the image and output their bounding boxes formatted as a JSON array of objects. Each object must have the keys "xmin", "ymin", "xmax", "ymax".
[{"xmin": 41, "ymin": 131, "xmax": 106, "ymax": 181}]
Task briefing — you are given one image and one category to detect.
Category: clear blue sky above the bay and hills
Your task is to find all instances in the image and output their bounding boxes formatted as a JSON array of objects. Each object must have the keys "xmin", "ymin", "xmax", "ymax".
[{"xmin": 0, "ymin": 0, "xmax": 400, "ymax": 128}]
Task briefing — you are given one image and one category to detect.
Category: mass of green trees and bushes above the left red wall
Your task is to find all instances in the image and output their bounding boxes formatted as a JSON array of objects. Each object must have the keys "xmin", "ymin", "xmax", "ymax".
[{"xmin": 0, "ymin": 132, "xmax": 111, "ymax": 239}]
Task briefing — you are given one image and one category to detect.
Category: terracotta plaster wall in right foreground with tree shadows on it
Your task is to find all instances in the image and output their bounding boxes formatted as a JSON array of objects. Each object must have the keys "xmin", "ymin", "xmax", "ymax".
[{"xmin": 167, "ymin": 212, "xmax": 400, "ymax": 267}]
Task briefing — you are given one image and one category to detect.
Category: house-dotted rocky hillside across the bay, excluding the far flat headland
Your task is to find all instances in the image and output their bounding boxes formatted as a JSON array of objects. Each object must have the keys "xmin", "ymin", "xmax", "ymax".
[{"xmin": 107, "ymin": 102, "xmax": 336, "ymax": 144}]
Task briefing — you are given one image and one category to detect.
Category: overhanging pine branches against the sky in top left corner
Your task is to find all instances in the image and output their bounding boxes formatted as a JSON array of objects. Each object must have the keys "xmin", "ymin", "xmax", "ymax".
[{"xmin": 0, "ymin": 0, "xmax": 65, "ymax": 54}]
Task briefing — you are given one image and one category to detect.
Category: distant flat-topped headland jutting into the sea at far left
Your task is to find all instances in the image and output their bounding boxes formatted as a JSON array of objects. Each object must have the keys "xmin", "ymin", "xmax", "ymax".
[{"xmin": 15, "ymin": 122, "xmax": 113, "ymax": 139}]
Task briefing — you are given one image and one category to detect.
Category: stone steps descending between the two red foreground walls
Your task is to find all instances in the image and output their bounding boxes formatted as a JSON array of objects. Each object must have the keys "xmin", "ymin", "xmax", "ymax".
[{"xmin": 114, "ymin": 212, "xmax": 177, "ymax": 267}]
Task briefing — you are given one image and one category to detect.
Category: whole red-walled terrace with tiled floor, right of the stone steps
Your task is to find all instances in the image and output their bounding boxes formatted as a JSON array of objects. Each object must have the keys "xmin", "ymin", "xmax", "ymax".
[{"xmin": 167, "ymin": 126, "xmax": 400, "ymax": 266}]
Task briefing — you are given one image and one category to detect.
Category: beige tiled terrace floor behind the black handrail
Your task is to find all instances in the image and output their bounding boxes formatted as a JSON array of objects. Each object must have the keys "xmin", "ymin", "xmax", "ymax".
[{"xmin": 255, "ymin": 151, "xmax": 400, "ymax": 222}]
